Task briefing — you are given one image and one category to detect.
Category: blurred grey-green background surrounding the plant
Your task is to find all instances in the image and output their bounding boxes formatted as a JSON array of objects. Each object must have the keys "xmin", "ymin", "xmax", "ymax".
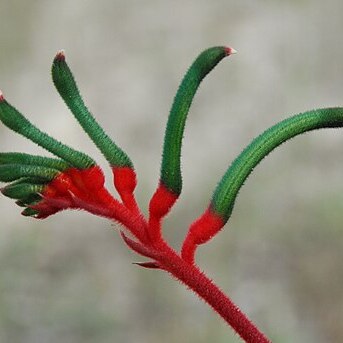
[{"xmin": 0, "ymin": 0, "xmax": 343, "ymax": 343}]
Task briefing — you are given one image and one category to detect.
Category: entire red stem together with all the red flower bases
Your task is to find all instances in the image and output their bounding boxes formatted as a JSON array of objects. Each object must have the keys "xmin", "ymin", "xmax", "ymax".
[{"xmin": 39, "ymin": 168, "xmax": 270, "ymax": 343}]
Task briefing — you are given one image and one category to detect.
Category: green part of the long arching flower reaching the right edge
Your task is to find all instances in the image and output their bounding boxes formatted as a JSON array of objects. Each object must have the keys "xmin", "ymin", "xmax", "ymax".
[{"xmin": 211, "ymin": 107, "xmax": 343, "ymax": 222}]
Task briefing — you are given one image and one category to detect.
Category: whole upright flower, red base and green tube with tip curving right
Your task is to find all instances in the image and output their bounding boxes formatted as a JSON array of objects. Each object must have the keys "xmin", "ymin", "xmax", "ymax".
[{"xmin": 149, "ymin": 46, "xmax": 236, "ymax": 245}]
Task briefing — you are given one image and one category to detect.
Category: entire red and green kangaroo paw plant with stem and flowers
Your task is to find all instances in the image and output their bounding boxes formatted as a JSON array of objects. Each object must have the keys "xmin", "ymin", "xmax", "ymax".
[{"xmin": 0, "ymin": 46, "xmax": 343, "ymax": 342}]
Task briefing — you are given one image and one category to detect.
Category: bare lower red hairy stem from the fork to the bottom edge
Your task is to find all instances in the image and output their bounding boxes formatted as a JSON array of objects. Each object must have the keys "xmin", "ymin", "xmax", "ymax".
[{"xmin": 157, "ymin": 242, "xmax": 271, "ymax": 343}]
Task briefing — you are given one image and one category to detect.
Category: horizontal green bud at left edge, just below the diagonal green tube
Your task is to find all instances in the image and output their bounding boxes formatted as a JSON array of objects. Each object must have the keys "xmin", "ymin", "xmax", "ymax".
[{"xmin": 0, "ymin": 164, "xmax": 60, "ymax": 182}]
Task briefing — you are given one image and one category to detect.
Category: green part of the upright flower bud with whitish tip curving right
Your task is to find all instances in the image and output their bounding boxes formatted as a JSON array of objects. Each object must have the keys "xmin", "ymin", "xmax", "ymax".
[{"xmin": 160, "ymin": 47, "xmax": 234, "ymax": 195}]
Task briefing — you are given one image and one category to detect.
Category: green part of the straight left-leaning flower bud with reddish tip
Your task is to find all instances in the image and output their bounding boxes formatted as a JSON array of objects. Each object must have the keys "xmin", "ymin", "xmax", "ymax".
[{"xmin": 52, "ymin": 52, "xmax": 133, "ymax": 168}]
